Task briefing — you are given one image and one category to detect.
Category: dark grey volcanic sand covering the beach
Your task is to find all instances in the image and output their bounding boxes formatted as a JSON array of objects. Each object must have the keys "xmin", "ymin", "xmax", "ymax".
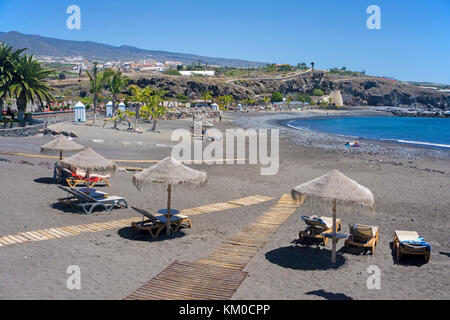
[{"xmin": 0, "ymin": 113, "xmax": 450, "ymax": 300}]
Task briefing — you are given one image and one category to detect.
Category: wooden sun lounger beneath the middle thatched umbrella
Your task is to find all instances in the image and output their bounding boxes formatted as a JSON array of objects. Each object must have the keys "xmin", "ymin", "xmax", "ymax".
[{"xmin": 131, "ymin": 207, "xmax": 192, "ymax": 239}]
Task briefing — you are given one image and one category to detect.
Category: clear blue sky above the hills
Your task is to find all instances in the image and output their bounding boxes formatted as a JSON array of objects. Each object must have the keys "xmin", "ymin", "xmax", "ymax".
[{"xmin": 0, "ymin": 0, "xmax": 450, "ymax": 84}]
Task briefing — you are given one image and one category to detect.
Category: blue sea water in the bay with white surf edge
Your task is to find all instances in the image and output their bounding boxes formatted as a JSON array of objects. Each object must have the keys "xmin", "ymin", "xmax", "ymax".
[{"xmin": 286, "ymin": 117, "xmax": 450, "ymax": 148}]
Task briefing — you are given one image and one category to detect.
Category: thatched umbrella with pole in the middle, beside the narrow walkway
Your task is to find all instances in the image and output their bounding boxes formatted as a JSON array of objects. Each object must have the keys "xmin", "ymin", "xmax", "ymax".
[{"xmin": 133, "ymin": 157, "xmax": 208, "ymax": 234}]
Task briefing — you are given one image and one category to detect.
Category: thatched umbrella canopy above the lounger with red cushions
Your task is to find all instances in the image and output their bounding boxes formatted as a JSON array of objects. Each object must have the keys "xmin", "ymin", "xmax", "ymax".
[{"xmin": 59, "ymin": 148, "xmax": 117, "ymax": 179}]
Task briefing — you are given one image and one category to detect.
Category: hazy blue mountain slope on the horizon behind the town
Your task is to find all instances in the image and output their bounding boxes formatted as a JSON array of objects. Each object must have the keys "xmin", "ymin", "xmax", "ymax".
[{"xmin": 0, "ymin": 31, "xmax": 266, "ymax": 67}]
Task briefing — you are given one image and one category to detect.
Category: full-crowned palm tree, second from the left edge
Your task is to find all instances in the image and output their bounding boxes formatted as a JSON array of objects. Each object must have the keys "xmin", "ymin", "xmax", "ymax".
[{"xmin": 10, "ymin": 55, "xmax": 54, "ymax": 121}]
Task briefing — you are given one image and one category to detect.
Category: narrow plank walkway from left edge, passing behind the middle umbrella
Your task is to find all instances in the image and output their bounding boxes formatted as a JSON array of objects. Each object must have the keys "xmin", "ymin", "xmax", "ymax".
[{"xmin": 0, "ymin": 195, "xmax": 273, "ymax": 247}]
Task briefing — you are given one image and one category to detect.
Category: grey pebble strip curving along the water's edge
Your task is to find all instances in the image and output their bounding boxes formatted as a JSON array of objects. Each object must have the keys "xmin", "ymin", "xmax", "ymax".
[{"xmin": 236, "ymin": 113, "xmax": 450, "ymax": 160}]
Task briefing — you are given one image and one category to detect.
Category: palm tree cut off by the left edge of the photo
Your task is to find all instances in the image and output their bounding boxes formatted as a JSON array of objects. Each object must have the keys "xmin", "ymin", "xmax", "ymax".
[{"xmin": 0, "ymin": 43, "xmax": 26, "ymax": 121}]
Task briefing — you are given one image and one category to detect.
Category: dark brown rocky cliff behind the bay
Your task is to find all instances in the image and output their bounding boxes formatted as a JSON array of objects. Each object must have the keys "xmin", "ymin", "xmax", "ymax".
[{"xmin": 128, "ymin": 71, "xmax": 450, "ymax": 111}]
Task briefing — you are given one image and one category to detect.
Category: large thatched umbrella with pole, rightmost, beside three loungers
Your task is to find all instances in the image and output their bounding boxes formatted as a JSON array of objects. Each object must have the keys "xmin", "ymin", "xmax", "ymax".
[{"xmin": 292, "ymin": 170, "xmax": 375, "ymax": 264}]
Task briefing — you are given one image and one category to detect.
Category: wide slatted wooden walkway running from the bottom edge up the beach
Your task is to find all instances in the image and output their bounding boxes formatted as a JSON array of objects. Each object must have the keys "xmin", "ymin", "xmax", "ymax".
[{"xmin": 125, "ymin": 195, "xmax": 300, "ymax": 300}]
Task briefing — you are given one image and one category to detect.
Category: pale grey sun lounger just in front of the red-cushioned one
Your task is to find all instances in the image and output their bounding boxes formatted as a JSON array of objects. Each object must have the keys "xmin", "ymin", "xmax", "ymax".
[{"xmin": 58, "ymin": 186, "xmax": 128, "ymax": 214}]
